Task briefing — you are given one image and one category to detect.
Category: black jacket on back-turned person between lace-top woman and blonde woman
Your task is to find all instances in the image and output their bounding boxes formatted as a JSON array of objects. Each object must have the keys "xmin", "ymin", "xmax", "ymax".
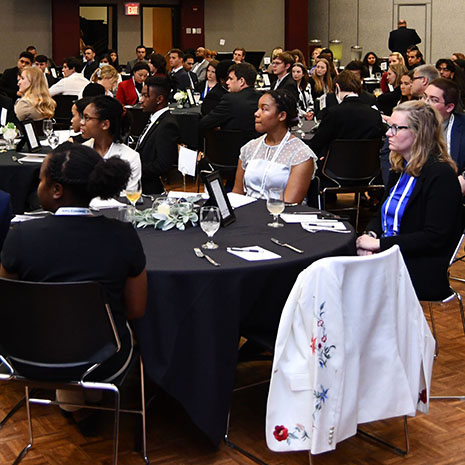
[{"xmin": 310, "ymin": 97, "xmax": 384, "ymax": 157}]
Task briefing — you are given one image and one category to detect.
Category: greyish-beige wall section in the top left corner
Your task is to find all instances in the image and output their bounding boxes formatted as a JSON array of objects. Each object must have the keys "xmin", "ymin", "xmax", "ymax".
[{"xmin": 0, "ymin": 0, "xmax": 52, "ymax": 72}]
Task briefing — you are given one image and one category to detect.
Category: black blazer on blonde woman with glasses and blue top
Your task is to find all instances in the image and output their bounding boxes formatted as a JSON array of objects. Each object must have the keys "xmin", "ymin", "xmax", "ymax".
[{"xmin": 367, "ymin": 159, "xmax": 463, "ymax": 300}]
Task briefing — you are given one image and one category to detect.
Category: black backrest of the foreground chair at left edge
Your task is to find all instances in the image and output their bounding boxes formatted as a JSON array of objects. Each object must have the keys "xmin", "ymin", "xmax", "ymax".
[{"xmin": 0, "ymin": 279, "xmax": 120, "ymax": 371}]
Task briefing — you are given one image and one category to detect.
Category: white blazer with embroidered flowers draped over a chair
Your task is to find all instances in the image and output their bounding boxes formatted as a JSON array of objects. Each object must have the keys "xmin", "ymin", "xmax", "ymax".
[{"xmin": 266, "ymin": 246, "xmax": 435, "ymax": 454}]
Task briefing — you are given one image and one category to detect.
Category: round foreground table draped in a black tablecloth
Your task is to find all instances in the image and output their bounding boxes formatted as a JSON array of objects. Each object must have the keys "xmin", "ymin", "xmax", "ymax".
[{"xmin": 134, "ymin": 201, "xmax": 355, "ymax": 445}]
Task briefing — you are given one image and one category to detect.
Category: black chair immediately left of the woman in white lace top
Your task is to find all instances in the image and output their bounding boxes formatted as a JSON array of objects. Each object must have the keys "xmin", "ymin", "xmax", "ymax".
[{"xmin": 204, "ymin": 129, "xmax": 249, "ymax": 183}]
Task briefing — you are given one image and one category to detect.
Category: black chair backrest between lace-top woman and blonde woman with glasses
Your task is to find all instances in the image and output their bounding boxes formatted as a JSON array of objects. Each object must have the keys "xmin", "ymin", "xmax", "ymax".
[{"xmin": 322, "ymin": 139, "xmax": 381, "ymax": 184}]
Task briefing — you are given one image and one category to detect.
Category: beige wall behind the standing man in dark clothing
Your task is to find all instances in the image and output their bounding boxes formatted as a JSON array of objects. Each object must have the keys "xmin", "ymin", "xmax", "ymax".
[{"xmin": 309, "ymin": 0, "xmax": 465, "ymax": 64}]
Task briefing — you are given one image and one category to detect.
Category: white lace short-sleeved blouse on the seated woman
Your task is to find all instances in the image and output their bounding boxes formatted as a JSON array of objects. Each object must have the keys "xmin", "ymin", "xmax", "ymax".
[{"xmin": 239, "ymin": 135, "xmax": 317, "ymax": 199}]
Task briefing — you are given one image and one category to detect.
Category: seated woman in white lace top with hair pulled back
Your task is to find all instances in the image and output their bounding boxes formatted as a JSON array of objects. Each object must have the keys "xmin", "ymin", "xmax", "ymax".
[{"xmin": 233, "ymin": 90, "xmax": 316, "ymax": 203}]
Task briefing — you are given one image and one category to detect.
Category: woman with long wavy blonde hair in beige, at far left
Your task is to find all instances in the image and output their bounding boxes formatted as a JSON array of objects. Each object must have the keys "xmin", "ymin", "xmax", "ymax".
[{"xmin": 15, "ymin": 66, "xmax": 56, "ymax": 121}]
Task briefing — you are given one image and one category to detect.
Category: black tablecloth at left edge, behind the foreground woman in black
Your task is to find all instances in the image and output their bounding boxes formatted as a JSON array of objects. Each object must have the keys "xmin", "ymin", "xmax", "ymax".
[{"xmin": 0, "ymin": 151, "xmax": 41, "ymax": 214}]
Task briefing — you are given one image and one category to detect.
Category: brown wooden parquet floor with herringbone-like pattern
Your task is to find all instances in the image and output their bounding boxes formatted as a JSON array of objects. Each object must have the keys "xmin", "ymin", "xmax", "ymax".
[{"xmin": 0, "ymin": 190, "xmax": 465, "ymax": 465}]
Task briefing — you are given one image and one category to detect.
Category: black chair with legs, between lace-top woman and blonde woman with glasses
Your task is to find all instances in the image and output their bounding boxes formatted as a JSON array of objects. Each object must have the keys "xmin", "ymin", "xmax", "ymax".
[{"xmin": 321, "ymin": 139, "xmax": 384, "ymax": 230}]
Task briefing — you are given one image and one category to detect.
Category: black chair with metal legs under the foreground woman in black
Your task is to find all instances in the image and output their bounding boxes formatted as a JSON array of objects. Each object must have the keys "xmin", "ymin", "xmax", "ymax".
[{"xmin": 0, "ymin": 279, "xmax": 149, "ymax": 464}]
